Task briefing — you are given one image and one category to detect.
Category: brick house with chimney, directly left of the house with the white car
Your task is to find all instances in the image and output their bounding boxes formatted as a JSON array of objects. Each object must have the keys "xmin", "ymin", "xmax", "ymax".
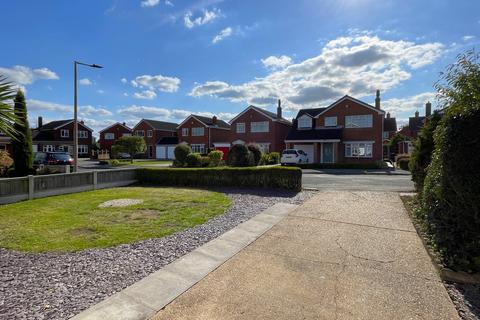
[{"xmin": 230, "ymin": 100, "xmax": 292, "ymax": 152}]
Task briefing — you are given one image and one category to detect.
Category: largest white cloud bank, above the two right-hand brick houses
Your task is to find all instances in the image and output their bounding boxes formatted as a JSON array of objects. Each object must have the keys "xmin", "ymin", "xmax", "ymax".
[{"xmin": 189, "ymin": 34, "xmax": 444, "ymax": 110}]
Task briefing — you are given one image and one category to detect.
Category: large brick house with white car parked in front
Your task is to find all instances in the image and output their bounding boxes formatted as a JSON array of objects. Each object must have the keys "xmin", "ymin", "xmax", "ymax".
[{"xmin": 285, "ymin": 91, "xmax": 385, "ymax": 163}]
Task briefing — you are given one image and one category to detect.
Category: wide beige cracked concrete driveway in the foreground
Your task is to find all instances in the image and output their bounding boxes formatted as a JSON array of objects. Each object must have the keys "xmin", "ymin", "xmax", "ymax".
[{"xmin": 153, "ymin": 191, "xmax": 458, "ymax": 320}]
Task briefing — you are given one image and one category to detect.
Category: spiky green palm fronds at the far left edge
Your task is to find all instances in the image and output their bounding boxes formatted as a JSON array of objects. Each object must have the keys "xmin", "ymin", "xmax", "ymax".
[{"xmin": 0, "ymin": 75, "xmax": 19, "ymax": 139}]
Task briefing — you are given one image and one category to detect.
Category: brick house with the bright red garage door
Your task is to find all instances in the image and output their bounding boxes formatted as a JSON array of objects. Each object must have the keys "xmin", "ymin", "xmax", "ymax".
[{"xmin": 177, "ymin": 114, "xmax": 230, "ymax": 157}]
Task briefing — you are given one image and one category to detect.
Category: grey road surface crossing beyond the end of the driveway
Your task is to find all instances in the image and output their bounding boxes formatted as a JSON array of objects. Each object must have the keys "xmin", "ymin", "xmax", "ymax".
[{"xmin": 302, "ymin": 170, "xmax": 414, "ymax": 192}]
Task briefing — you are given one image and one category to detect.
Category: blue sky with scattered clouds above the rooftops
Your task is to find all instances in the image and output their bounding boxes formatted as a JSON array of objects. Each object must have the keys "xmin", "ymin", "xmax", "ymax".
[{"xmin": 0, "ymin": 0, "xmax": 480, "ymax": 132}]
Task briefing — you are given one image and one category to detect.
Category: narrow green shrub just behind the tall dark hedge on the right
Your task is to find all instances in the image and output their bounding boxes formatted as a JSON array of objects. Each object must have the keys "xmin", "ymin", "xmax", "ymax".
[{"xmin": 408, "ymin": 111, "xmax": 441, "ymax": 192}]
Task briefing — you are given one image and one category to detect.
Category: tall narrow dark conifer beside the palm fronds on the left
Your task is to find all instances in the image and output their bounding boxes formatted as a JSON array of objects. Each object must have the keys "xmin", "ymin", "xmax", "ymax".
[{"xmin": 12, "ymin": 90, "xmax": 33, "ymax": 176}]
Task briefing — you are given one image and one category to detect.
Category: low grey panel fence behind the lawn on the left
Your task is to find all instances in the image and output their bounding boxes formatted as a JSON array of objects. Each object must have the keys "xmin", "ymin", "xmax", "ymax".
[{"xmin": 0, "ymin": 168, "xmax": 137, "ymax": 204}]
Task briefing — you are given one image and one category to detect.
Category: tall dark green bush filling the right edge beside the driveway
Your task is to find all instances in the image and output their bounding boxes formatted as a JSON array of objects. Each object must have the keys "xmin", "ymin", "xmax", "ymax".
[{"xmin": 420, "ymin": 52, "xmax": 480, "ymax": 271}]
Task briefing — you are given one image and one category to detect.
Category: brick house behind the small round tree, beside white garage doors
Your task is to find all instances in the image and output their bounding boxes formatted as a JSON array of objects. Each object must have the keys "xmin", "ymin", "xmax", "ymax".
[{"xmin": 132, "ymin": 119, "xmax": 178, "ymax": 159}]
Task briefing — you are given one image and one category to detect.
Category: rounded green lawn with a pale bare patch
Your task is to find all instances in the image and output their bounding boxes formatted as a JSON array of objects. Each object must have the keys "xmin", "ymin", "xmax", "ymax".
[{"xmin": 0, "ymin": 187, "xmax": 230, "ymax": 252}]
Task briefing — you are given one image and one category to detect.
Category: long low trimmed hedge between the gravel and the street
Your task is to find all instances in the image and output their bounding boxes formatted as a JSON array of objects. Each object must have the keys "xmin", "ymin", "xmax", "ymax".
[{"xmin": 137, "ymin": 167, "xmax": 302, "ymax": 191}]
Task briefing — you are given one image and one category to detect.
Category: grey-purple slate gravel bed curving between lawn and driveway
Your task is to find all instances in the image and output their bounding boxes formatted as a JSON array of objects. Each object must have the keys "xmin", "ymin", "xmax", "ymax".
[{"xmin": 0, "ymin": 189, "xmax": 313, "ymax": 320}]
